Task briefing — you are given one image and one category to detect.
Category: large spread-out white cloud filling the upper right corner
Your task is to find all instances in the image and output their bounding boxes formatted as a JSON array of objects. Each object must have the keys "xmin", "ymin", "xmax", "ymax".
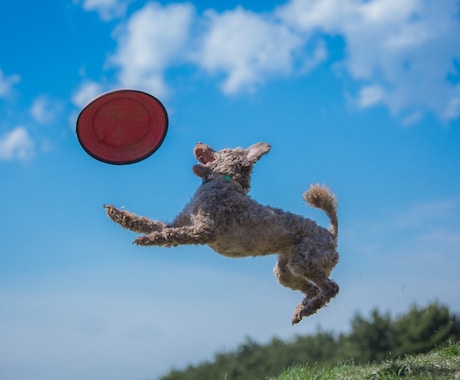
[{"xmin": 276, "ymin": 0, "xmax": 460, "ymax": 120}]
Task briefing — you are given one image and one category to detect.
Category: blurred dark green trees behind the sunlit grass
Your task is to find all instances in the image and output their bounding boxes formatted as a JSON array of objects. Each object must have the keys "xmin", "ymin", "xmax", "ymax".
[{"xmin": 161, "ymin": 303, "xmax": 460, "ymax": 380}]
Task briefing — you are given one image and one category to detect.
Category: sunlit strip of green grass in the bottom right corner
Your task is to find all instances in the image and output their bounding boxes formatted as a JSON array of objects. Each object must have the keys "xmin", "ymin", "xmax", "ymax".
[{"xmin": 271, "ymin": 342, "xmax": 460, "ymax": 380}]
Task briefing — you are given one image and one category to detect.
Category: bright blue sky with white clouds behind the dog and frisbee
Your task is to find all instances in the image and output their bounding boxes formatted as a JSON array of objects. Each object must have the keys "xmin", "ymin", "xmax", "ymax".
[{"xmin": 0, "ymin": 0, "xmax": 460, "ymax": 380}]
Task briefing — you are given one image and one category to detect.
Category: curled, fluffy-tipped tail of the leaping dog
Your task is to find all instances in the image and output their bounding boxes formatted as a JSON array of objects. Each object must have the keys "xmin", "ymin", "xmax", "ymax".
[{"xmin": 303, "ymin": 185, "xmax": 339, "ymax": 241}]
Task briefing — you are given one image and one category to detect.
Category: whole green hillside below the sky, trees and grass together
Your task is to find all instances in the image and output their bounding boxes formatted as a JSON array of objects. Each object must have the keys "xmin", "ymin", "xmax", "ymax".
[{"xmin": 161, "ymin": 303, "xmax": 460, "ymax": 380}]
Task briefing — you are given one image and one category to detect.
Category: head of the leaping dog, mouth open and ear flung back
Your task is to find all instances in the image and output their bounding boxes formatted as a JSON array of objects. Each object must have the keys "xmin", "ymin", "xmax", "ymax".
[{"xmin": 193, "ymin": 142, "xmax": 270, "ymax": 190}]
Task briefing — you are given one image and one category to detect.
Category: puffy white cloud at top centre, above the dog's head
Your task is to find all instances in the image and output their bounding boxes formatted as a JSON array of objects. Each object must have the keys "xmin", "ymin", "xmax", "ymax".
[{"xmin": 196, "ymin": 7, "xmax": 304, "ymax": 94}]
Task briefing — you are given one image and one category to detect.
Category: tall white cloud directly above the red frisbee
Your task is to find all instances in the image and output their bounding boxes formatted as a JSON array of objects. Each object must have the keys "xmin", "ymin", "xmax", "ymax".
[{"xmin": 110, "ymin": 3, "xmax": 194, "ymax": 96}]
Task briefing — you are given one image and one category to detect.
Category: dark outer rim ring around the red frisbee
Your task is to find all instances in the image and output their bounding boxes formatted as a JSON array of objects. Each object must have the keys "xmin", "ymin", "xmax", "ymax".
[{"xmin": 76, "ymin": 88, "xmax": 169, "ymax": 165}]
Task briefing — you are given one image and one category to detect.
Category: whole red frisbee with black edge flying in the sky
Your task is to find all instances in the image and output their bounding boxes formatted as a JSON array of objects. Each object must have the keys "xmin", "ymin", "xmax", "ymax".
[{"xmin": 77, "ymin": 90, "xmax": 168, "ymax": 165}]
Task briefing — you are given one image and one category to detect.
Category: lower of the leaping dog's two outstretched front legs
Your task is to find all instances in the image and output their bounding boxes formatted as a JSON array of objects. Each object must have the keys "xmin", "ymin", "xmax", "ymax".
[{"xmin": 134, "ymin": 225, "xmax": 216, "ymax": 247}]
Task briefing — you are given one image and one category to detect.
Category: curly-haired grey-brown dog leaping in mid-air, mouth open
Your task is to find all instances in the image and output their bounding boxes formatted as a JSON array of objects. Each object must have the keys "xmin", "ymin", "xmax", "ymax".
[{"xmin": 104, "ymin": 142, "xmax": 339, "ymax": 324}]
